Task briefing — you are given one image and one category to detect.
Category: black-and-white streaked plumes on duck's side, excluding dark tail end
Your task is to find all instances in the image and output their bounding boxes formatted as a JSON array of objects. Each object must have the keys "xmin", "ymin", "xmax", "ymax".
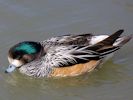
[{"xmin": 44, "ymin": 46, "xmax": 100, "ymax": 67}]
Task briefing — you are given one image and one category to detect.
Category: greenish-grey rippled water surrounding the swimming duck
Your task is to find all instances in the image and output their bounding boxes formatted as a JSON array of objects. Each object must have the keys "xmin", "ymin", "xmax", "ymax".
[{"xmin": 0, "ymin": 0, "xmax": 133, "ymax": 100}]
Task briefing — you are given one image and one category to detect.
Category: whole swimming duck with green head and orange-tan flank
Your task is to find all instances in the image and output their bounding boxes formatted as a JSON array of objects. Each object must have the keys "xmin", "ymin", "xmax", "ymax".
[{"xmin": 5, "ymin": 29, "xmax": 132, "ymax": 78}]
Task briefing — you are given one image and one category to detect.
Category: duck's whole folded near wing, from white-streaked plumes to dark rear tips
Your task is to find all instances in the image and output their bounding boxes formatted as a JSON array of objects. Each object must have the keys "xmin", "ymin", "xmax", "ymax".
[{"xmin": 44, "ymin": 30, "xmax": 131, "ymax": 67}]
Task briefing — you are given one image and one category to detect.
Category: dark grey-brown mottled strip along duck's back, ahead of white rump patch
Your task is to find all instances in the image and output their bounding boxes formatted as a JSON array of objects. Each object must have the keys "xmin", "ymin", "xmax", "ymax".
[{"xmin": 42, "ymin": 33, "xmax": 93, "ymax": 46}]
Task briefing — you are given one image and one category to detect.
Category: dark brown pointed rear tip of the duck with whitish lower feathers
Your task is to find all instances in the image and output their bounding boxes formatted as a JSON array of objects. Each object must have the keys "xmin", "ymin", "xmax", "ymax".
[{"xmin": 87, "ymin": 29, "xmax": 133, "ymax": 57}]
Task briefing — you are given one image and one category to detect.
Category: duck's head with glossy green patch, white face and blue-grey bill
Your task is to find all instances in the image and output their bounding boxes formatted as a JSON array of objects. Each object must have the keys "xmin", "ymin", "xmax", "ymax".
[{"xmin": 5, "ymin": 41, "xmax": 44, "ymax": 73}]
